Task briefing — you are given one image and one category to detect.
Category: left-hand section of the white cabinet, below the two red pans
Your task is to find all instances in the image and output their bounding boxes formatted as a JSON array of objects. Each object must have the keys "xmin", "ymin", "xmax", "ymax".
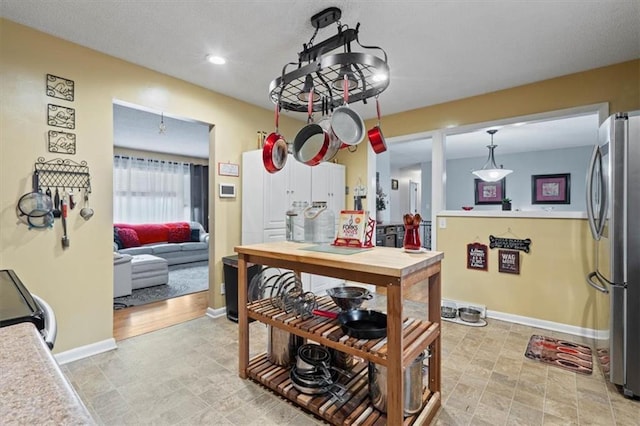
[{"xmin": 259, "ymin": 155, "xmax": 311, "ymax": 229}]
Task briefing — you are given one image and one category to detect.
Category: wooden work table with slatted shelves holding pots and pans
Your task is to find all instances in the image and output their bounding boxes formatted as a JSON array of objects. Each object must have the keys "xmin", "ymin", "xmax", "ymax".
[{"xmin": 235, "ymin": 242, "xmax": 444, "ymax": 426}]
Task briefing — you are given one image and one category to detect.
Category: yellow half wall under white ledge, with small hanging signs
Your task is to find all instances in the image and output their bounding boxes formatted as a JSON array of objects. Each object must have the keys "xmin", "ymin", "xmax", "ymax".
[{"xmin": 436, "ymin": 217, "xmax": 608, "ymax": 330}]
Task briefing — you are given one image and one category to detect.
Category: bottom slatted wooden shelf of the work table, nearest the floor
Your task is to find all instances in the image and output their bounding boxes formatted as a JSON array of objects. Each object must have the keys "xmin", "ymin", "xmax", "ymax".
[{"xmin": 247, "ymin": 354, "xmax": 440, "ymax": 426}]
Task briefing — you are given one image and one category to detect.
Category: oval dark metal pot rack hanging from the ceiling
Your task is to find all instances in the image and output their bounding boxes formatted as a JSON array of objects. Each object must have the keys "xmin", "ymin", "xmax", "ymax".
[{"xmin": 269, "ymin": 7, "xmax": 389, "ymax": 112}]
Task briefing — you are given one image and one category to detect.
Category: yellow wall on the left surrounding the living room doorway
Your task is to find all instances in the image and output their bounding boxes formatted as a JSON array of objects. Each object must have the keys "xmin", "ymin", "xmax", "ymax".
[{"xmin": 0, "ymin": 20, "xmax": 300, "ymax": 352}]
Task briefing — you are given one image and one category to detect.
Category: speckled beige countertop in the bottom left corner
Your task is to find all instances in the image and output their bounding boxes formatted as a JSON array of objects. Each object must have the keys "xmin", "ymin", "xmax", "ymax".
[{"xmin": 0, "ymin": 322, "xmax": 95, "ymax": 425}]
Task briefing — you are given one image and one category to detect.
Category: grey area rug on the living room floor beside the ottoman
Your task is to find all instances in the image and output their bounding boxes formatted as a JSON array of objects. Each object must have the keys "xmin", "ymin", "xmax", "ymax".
[{"xmin": 113, "ymin": 261, "xmax": 209, "ymax": 309}]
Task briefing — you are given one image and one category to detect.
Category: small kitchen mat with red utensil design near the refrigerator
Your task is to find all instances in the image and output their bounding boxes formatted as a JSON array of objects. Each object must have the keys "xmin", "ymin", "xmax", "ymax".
[{"xmin": 524, "ymin": 334, "xmax": 593, "ymax": 374}]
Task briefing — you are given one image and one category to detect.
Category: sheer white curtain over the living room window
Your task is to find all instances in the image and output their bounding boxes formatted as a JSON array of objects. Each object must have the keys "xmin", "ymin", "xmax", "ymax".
[{"xmin": 113, "ymin": 156, "xmax": 191, "ymax": 223}]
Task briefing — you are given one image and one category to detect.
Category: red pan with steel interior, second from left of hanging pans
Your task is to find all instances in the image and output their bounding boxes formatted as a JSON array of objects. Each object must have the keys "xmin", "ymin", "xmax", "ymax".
[{"xmin": 293, "ymin": 88, "xmax": 331, "ymax": 166}]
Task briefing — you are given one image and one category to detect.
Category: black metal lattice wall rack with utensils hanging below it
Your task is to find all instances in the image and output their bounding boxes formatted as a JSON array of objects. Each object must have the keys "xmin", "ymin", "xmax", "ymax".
[{"xmin": 33, "ymin": 157, "xmax": 91, "ymax": 192}]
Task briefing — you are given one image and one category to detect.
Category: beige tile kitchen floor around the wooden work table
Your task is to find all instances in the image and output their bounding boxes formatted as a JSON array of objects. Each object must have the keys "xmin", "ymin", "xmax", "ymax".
[{"xmin": 62, "ymin": 309, "xmax": 640, "ymax": 426}]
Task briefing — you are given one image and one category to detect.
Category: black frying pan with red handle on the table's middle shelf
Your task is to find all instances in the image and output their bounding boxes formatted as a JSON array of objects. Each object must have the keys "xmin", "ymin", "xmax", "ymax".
[{"xmin": 313, "ymin": 309, "xmax": 387, "ymax": 339}]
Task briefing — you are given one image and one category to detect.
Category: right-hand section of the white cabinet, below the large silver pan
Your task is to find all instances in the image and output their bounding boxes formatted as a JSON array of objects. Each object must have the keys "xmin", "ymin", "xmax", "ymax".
[{"xmin": 311, "ymin": 163, "xmax": 345, "ymax": 220}]
